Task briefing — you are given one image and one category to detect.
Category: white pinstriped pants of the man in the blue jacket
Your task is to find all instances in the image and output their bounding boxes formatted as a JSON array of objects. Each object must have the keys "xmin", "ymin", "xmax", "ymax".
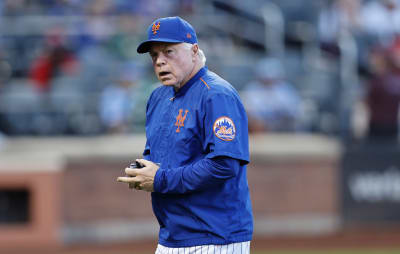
[{"xmin": 155, "ymin": 241, "xmax": 250, "ymax": 254}]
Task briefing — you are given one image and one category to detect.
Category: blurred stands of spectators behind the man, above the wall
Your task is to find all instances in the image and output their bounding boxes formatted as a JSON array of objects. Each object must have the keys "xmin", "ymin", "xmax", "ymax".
[{"xmin": 0, "ymin": 0, "xmax": 400, "ymax": 141}]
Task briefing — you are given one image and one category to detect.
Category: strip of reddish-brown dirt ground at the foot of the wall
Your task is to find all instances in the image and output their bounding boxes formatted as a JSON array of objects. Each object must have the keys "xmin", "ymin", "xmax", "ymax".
[{"xmin": 5, "ymin": 229, "xmax": 400, "ymax": 254}]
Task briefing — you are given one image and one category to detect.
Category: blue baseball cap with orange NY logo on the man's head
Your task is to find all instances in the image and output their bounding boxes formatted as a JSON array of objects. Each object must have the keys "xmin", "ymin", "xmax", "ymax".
[{"xmin": 137, "ymin": 17, "xmax": 197, "ymax": 54}]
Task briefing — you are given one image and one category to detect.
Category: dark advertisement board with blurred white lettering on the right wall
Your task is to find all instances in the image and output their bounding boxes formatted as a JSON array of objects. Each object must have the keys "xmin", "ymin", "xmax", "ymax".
[{"xmin": 341, "ymin": 145, "xmax": 400, "ymax": 224}]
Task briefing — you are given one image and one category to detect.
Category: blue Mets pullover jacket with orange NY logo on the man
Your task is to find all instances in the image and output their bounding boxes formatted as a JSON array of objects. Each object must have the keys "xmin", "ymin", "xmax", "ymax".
[{"xmin": 143, "ymin": 67, "xmax": 253, "ymax": 247}]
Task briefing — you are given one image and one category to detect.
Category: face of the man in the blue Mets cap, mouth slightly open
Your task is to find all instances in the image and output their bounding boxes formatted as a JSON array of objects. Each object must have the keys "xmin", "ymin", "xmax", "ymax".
[{"xmin": 150, "ymin": 42, "xmax": 195, "ymax": 89}]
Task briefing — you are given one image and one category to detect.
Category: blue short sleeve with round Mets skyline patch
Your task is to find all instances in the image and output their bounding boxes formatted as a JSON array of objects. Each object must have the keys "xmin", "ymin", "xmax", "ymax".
[{"xmin": 204, "ymin": 91, "xmax": 249, "ymax": 164}]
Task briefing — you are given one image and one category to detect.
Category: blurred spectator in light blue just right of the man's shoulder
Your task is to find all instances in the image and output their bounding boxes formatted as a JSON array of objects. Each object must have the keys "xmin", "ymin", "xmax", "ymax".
[{"xmin": 241, "ymin": 58, "xmax": 301, "ymax": 132}]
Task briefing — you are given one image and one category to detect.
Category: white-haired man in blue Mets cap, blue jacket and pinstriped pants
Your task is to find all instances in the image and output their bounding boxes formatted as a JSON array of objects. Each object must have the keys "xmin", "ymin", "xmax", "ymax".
[{"xmin": 118, "ymin": 17, "xmax": 253, "ymax": 254}]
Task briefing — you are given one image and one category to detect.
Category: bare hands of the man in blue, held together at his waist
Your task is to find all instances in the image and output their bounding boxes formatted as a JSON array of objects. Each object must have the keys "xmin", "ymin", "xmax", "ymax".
[{"xmin": 117, "ymin": 159, "xmax": 160, "ymax": 192}]
